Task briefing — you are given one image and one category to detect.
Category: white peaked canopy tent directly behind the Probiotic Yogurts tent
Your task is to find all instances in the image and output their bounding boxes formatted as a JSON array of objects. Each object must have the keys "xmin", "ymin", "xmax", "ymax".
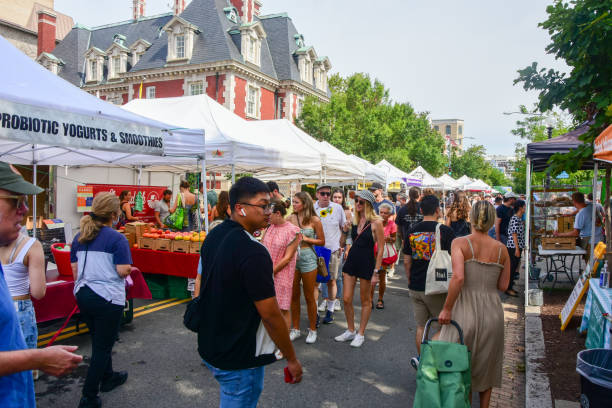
[{"xmin": 123, "ymin": 95, "xmax": 321, "ymax": 178}]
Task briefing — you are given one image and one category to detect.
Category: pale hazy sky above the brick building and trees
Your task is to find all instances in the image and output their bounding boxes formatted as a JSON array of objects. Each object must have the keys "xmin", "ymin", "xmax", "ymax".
[{"xmin": 55, "ymin": 0, "xmax": 567, "ymax": 155}]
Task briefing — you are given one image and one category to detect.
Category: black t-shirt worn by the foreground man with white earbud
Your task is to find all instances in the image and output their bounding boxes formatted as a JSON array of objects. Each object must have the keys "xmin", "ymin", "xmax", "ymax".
[{"xmin": 198, "ymin": 220, "xmax": 276, "ymax": 370}]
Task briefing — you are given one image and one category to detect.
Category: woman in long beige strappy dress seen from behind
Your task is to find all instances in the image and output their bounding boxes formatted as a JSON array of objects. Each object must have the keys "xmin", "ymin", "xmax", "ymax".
[{"xmin": 438, "ymin": 201, "xmax": 510, "ymax": 407}]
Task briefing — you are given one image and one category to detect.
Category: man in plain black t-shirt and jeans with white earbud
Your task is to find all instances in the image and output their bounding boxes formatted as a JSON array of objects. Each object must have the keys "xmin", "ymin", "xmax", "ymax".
[{"xmin": 198, "ymin": 177, "xmax": 302, "ymax": 407}]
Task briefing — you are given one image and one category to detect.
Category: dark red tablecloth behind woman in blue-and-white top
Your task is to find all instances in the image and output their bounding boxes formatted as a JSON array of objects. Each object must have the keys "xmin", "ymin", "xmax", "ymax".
[{"xmin": 32, "ymin": 267, "xmax": 151, "ymax": 323}]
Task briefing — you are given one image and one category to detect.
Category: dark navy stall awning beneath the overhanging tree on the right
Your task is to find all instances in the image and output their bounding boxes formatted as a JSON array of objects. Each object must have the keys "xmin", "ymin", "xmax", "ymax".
[{"xmin": 525, "ymin": 122, "xmax": 593, "ymax": 171}]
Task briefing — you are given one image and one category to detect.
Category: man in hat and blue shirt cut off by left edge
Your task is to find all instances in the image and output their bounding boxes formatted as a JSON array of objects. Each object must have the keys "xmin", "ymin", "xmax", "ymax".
[{"xmin": 0, "ymin": 162, "xmax": 83, "ymax": 408}]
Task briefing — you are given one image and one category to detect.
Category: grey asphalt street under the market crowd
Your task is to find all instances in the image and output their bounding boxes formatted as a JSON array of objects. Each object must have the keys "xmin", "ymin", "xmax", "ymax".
[{"xmin": 36, "ymin": 266, "xmax": 416, "ymax": 408}]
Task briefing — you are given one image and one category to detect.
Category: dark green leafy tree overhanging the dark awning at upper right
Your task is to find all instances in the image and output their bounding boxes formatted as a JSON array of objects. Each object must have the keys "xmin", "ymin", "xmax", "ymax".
[{"xmin": 514, "ymin": 0, "xmax": 612, "ymax": 174}]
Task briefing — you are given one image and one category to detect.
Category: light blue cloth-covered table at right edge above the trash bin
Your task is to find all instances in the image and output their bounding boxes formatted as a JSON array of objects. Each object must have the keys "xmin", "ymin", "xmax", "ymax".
[{"xmin": 580, "ymin": 278, "xmax": 612, "ymax": 349}]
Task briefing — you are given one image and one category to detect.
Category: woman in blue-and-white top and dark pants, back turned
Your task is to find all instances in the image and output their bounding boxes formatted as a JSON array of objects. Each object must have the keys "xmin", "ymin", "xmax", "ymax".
[{"xmin": 70, "ymin": 193, "xmax": 132, "ymax": 408}]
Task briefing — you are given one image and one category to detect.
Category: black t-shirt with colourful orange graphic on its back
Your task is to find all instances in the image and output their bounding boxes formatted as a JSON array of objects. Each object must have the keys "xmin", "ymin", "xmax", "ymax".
[{"xmin": 404, "ymin": 221, "xmax": 455, "ymax": 292}]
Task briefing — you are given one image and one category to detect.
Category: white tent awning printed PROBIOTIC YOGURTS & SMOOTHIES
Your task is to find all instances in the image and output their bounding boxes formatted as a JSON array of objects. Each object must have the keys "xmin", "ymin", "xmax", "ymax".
[{"xmin": 0, "ymin": 33, "xmax": 203, "ymax": 165}]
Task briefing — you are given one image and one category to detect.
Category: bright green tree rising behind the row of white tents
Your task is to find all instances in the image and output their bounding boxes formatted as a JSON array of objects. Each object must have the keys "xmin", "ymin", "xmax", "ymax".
[{"xmin": 297, "ymin": 73, "xmax": 446, "ymax": 176}]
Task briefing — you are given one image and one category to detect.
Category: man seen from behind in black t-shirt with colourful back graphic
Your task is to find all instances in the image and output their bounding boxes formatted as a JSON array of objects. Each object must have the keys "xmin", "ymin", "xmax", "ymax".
[{"xmin": 404, "ymin": 195, "xmax": 455, "ymax": 354}]
